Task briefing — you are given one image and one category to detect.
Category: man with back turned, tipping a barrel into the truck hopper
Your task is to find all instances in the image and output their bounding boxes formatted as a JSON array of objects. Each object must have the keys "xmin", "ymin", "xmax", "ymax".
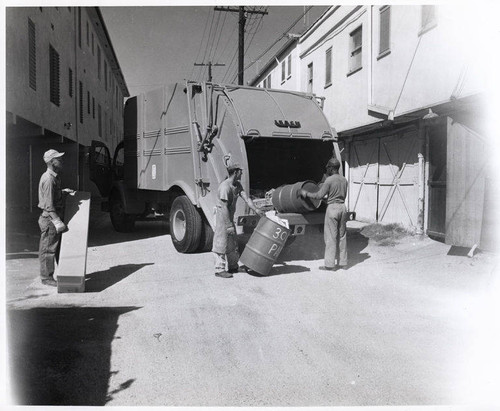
[{"xmin": 300, "ymin": 158, "xmax": 347, "ymax": 271}]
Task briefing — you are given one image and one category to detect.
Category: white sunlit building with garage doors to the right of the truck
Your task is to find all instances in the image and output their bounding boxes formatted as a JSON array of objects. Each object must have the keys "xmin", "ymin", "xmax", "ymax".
[{"xmin": 251, "ymin": 5, "xmax": 498, "ymax": 248}]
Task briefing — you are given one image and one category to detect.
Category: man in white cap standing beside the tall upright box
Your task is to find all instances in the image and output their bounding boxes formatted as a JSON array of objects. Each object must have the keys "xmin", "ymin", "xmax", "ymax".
[{"xmin": 38, "ymin": 149, "xmax": 74, "ymax": 286}]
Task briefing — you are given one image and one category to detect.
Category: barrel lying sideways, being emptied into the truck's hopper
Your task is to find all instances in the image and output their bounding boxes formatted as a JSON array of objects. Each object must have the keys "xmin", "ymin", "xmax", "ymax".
[{"xmin": 271, "ymin": 181, "xmax": 321, "ymax": 213}]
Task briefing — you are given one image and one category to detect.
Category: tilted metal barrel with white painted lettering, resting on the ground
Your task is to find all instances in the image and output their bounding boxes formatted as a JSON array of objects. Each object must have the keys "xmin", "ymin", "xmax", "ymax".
[{"xmin": 240, "ymin": 217, "xmax": 292, "ymax": 275}]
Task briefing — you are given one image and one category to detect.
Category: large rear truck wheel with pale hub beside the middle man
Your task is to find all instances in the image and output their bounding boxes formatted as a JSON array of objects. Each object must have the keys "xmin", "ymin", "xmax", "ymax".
[{"xmin": 170, "ymin": 195, "xmax": 203, "ymax": 253}]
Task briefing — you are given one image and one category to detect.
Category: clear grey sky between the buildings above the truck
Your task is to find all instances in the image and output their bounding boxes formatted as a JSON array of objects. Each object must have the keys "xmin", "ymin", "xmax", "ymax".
[{"xmin": 101, "ymin": 6, "xmax": 327, "ymax": 96}]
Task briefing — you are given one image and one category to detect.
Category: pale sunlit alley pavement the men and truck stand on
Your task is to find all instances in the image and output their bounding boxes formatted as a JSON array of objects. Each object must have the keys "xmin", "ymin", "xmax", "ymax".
[{"xmin": 6, "ymin": 209, "xmax": 500, "ymax": 409}]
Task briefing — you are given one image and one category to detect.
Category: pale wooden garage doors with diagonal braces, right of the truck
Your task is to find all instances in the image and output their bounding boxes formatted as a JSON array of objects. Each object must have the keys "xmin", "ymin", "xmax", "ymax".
[{"xmin": 349, "ymin": 129, "xmax": 419, "ymax": 227}]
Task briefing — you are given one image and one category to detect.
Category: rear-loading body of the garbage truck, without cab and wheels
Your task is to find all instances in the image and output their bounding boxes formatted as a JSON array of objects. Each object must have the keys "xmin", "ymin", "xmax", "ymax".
[{"xmin": 124, "ymin": 82, "xmax": 340, "ymax": 227}]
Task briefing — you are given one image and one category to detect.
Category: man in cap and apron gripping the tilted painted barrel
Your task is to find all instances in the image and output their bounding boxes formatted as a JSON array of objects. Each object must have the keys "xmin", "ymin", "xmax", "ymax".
[{"xmin": 212, "ymin": 160, "xmax": 263, "ymax": 278}]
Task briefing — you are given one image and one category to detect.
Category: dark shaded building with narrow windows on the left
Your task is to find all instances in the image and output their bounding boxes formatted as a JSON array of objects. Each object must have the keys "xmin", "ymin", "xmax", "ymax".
[{"xmin": 6, "ymin": 7, "xmax": 129, "ymax": 213}]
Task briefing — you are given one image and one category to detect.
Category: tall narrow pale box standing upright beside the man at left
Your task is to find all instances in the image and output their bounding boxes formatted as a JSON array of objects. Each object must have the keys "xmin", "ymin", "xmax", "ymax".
[{"xmin": 54, "ymin": 191, "xmax": 90, "ymax": 293}]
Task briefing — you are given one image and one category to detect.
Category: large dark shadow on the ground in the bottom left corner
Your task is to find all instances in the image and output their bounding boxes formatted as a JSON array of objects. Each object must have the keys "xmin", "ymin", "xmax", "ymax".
[{"xmin": 7, "ymin": 307, "xmax": 140, "ymax": 406}]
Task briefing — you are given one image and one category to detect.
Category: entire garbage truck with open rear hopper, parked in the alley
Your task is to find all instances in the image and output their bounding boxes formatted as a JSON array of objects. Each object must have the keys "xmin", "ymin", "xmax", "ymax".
[{"xmin": 89, "ymin": 81, "xmax": 340, "ymax": 253}]
